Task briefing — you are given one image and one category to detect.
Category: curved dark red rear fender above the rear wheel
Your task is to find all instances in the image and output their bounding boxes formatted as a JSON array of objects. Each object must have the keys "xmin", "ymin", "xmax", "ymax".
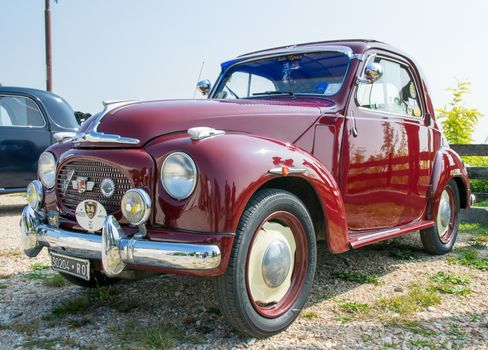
[{"xmin": 427, "ymin": 147, "xmax": 471, "ymax": 219}]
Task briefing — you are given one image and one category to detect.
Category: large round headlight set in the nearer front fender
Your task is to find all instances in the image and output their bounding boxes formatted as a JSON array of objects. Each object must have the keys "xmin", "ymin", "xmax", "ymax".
[{"xmin": 161, "ymin": 152, "xmax": 197, "ymax": 200}]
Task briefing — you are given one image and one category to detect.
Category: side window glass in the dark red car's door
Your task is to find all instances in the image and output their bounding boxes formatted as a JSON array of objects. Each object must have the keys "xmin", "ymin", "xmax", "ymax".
[{"xmin": 356, "ymin": 56, "xmax": 422, "ymax": 117}]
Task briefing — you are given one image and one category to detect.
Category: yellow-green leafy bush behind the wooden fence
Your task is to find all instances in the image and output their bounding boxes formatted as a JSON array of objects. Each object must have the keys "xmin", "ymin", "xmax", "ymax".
[{"xmin": 437, "ymin": 81, "xmax": 483, "ymax": 144}]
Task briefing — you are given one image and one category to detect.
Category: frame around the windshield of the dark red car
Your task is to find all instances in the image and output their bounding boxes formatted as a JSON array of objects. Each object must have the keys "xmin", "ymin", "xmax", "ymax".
[{"xmin": 208, "ymin": 46, "xmax": 354, "ymax": 100}]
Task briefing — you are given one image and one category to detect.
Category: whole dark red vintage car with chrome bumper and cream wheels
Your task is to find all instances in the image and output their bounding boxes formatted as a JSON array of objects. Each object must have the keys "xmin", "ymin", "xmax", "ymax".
[{"xmin": 21, "ymin": 40, "xmax": 472, "ymax": 337}]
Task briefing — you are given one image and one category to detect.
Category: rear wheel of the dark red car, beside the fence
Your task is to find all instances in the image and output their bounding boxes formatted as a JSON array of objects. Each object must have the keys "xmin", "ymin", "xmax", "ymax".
[{"xmin": 420, "ymin": 179, "xmax": 459, "ymax": 255}]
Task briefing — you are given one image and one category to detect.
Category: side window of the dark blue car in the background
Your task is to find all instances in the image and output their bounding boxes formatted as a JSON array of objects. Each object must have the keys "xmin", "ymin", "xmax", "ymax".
[{"xmin": 0, "ymin": 96, "xmax": 45, "ymax": 127}]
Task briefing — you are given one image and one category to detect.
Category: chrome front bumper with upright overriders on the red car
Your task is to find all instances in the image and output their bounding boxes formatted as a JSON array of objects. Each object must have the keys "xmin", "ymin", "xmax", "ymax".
[{"xmin": 20, "ymin": 206, "xmax": 221, "ymax": 277}]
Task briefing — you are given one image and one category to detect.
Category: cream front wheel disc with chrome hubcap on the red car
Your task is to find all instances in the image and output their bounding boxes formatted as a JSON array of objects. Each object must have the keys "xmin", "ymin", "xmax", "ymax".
[{"xmin": 248, "ymin": 221, "xmax": 296, "ymax": 305}]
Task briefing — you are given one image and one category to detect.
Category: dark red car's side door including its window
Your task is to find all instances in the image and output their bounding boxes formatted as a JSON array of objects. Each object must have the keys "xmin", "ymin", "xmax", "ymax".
[{"xmin": 340, "ymin": 53, "xmax": 430, "ymax": 230}]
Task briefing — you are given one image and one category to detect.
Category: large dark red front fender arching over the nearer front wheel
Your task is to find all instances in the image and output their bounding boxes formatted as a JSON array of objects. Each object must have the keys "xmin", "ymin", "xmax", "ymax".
[{"xmin": 146, "ymin": 133, "xmax": 348, "ymax": 252}]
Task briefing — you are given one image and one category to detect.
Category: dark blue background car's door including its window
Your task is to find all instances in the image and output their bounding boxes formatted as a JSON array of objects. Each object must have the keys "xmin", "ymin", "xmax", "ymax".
[{"xmin": 0, "ymin": 94, "xmax": 51, "ymax": 191}]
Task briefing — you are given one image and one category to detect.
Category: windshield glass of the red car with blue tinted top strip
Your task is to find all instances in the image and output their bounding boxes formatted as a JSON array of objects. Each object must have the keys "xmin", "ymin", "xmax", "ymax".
[{"xmin": 212, "ymin": 52, "xmax": 350, "ymax": 99}]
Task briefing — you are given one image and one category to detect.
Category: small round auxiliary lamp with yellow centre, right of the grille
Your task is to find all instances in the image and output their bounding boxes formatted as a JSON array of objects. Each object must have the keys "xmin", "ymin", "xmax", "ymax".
[{"xmin": 120, "ymin": 188, "xmax": 151, "ymax": 225}]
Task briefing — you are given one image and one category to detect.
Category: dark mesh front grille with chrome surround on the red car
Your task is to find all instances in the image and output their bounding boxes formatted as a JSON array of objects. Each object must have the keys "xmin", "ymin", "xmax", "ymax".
[{"xmin": 56, "ymin": 161, "xmax": 131, "ymax": 215}]
